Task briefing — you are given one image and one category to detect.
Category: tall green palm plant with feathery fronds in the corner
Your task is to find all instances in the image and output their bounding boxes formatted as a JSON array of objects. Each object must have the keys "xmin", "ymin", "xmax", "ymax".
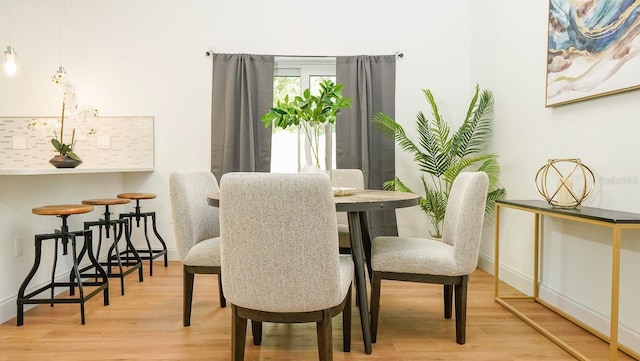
[{"xmin": 373, "ymin": 85, "xmax": 506, "ymax": 238}]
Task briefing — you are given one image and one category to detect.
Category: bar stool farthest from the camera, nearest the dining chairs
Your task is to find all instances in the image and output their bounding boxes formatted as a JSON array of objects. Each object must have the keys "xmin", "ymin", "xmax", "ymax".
[{"xmin": 117, "ymin": 193, "xmax": 169, "ymax": 276}]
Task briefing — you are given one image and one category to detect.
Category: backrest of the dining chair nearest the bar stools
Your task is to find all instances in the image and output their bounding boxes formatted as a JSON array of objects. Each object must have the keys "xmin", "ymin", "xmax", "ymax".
[{"xmin": 169, "ymin": 171, "xmax": 220, "ymax": 260}]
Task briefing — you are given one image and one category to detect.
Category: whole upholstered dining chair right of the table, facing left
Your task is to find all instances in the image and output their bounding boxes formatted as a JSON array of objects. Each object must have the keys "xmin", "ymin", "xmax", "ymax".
[{"xmin": 371, "ymin": 172, "xmax": 489, "ymax": 345}]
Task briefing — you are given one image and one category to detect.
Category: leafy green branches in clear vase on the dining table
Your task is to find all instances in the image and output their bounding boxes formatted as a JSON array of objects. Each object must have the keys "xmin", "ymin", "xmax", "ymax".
[{"xmin": 260, "ymin": 80, "xmax": 351, "ymax": 168}]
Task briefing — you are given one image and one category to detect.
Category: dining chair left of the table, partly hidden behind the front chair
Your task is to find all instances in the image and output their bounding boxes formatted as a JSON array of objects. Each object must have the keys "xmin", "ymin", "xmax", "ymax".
[{"xmin": 169, "ymin": 171, "xmax": 226, "ymax": 327}]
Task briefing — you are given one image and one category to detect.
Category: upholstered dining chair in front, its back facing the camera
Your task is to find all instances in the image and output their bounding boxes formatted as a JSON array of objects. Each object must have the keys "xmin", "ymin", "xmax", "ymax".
[{"xmin": 220, "ymin": 173, "xmax": 354, "ymax": 360}]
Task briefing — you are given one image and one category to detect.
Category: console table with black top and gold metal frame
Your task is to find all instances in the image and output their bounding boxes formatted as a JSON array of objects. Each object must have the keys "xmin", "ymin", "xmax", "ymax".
[{"xmin": 494, "ymin": 200, "xmax": 640, "ymax": 360}]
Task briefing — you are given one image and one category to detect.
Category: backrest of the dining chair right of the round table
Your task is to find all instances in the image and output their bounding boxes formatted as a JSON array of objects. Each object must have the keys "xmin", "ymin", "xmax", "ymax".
[{"xmin": 442, "ymin": 172, "xmax": 489, "ymax": 274}]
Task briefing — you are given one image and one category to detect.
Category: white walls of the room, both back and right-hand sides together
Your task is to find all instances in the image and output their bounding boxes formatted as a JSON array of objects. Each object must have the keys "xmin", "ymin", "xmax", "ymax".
[{"xmin": 0, "ymin": 0, "xmax": 640, "ymax": 349}]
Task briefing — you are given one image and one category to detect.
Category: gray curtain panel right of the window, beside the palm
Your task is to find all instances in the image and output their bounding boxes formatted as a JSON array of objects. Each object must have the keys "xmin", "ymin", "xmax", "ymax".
[{"xmin": 336, "ymin": 55, "xmax": 398, "ymax": 238}]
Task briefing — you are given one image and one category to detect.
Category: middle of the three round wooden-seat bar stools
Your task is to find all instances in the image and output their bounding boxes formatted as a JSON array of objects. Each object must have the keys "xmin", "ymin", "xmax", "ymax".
[{"xmin": 71, "ymin": 198, "xmax": 143, "ymax": 295}]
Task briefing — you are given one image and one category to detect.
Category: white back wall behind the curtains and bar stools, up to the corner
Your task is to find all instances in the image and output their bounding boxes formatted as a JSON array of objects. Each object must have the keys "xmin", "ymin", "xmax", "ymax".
[{"xmin": 0, "ymin": 0, "xmax": 473, "ymax": 323}]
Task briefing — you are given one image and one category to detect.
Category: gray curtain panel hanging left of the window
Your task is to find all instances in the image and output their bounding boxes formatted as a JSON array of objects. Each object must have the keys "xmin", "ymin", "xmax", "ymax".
[{"xmin": 211, "ymin": 54, "xmax": 274, "ymax": 181}]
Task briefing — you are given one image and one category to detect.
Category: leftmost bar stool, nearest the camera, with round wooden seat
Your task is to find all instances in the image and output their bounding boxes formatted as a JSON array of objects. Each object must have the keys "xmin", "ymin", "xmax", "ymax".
[{"xmin": 16, "ymin": 204, "xmax": 109, "ymax": 326}]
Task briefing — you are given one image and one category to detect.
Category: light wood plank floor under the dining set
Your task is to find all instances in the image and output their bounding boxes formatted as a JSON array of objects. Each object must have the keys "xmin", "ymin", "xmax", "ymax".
[{"xmin": 0, "ymin": 262, "xmax": 630, "ymax": 361}]
